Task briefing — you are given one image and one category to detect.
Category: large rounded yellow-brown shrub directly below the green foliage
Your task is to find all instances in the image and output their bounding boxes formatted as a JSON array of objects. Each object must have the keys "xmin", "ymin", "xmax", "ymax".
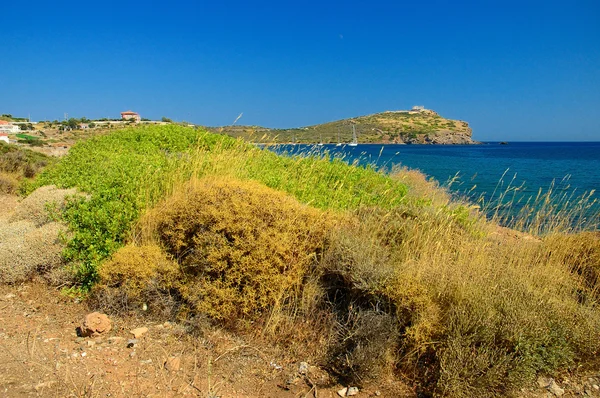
[{"xmin": 140, "ymin": 178, "xmax": 330, "ymax": 321}]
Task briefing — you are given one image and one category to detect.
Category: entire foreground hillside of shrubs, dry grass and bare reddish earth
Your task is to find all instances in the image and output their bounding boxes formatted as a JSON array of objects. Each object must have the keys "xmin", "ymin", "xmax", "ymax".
[{"xmin": 0, "ymin": 125, "xmax": 600, "ymax": 398}]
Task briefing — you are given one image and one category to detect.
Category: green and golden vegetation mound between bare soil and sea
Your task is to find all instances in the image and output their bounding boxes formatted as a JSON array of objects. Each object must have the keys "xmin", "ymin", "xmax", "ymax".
[{"xmin": 5, "ymin": 126, "xmax": 600, "ymax": 397}]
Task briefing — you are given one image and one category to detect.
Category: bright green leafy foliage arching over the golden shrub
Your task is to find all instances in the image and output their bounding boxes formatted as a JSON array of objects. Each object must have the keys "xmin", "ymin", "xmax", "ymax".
[{"xmin": 29, "ymin": 125, "xmax": 406, "ymax": 287}]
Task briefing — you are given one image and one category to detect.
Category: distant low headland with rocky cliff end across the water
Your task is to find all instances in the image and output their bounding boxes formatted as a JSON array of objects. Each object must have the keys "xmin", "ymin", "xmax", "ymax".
[{"xmin": 207, "ymin": 107, "xmax": 477, "ymax": 144}]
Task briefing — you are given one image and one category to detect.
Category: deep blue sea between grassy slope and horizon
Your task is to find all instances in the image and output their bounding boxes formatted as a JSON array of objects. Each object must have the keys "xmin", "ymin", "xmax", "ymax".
[{"xmin": 275, "ymin": 142, "xmax": 600, "ymax": 229}]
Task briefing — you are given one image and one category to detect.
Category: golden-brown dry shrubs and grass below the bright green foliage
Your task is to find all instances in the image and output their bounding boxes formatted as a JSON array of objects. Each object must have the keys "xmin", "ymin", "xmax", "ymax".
[{"xmin": 88, "ymin": 170, "xmax": 600, "ymax": 397}]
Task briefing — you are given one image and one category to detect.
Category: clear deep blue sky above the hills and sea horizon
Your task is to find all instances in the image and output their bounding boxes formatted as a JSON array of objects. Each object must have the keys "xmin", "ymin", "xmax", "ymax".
[{"xmin": 0, "ymin": 0, "xmax": 600, "ymax": 141}]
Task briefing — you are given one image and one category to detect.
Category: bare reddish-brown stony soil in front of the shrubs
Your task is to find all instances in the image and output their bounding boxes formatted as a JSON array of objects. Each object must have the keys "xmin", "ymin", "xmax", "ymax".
[{"xmin": 0, "ymin": 281, "xmax": 415, "ymax": 398}]
